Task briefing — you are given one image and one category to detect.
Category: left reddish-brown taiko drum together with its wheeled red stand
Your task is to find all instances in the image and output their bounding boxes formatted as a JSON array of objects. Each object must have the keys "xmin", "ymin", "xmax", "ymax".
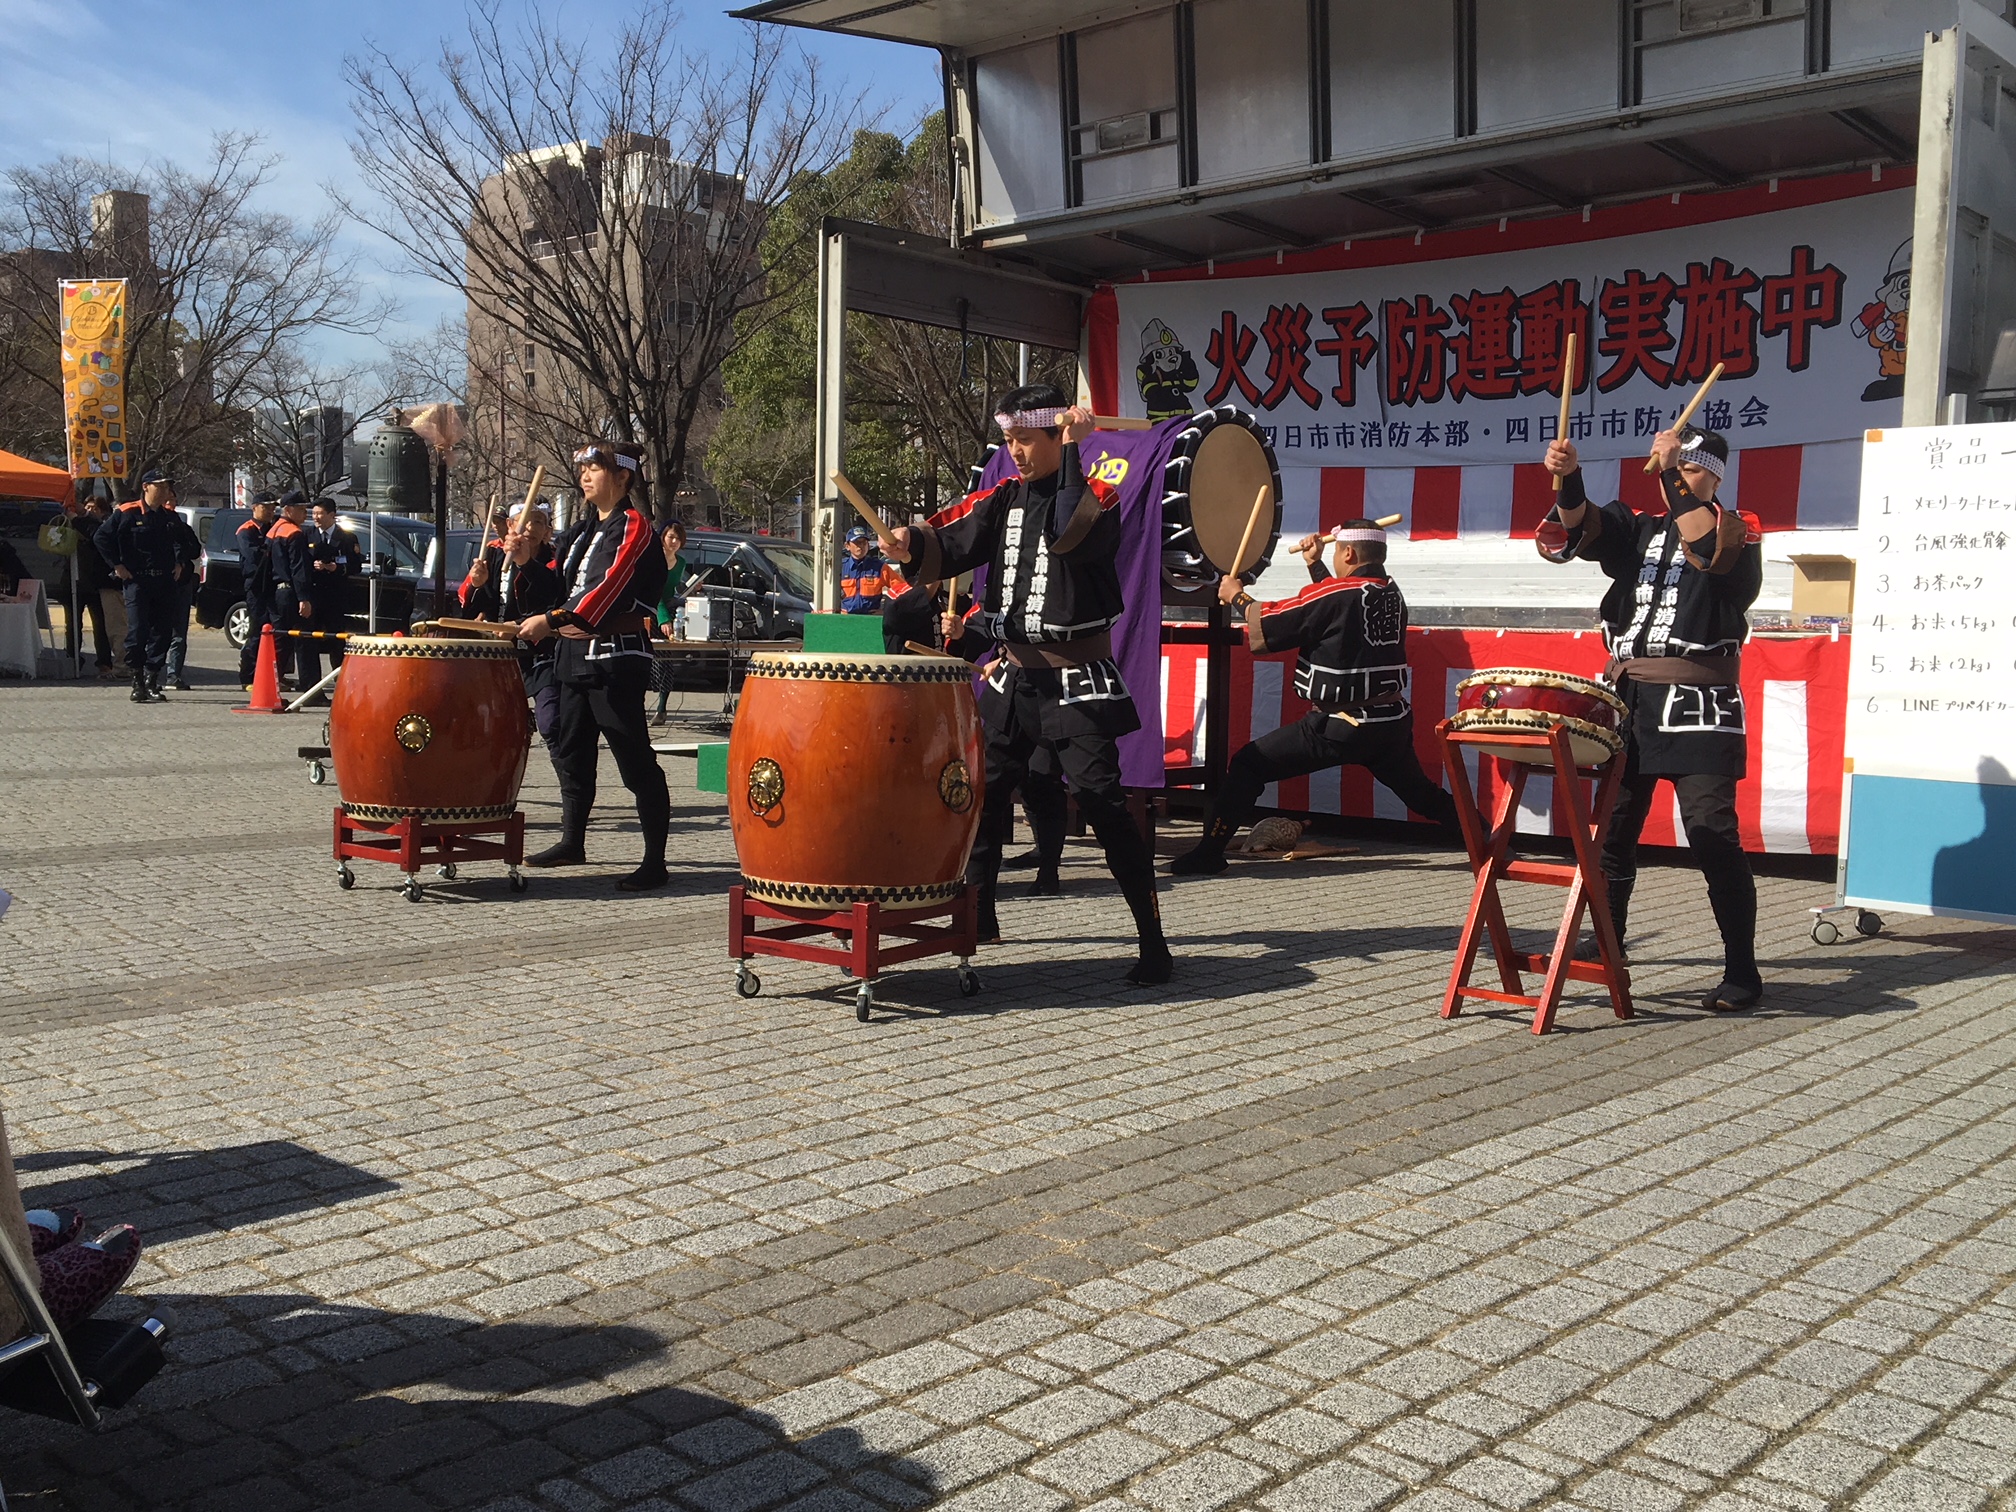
[{"xmin": 329, "ymin": 635, "xmax": 530, "ymax": 901}]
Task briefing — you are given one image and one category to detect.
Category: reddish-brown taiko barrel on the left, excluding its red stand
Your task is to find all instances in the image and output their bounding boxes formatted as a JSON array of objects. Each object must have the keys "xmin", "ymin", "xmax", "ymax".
[{"xmin": 329, "ymin": 635, "xmax": 528, "ymax": 825}]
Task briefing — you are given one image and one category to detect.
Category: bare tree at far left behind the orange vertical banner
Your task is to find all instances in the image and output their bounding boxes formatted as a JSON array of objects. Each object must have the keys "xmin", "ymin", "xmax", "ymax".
[{"xmin": 0, "ymin": 133, "xmax": 389, "ymax": 478}]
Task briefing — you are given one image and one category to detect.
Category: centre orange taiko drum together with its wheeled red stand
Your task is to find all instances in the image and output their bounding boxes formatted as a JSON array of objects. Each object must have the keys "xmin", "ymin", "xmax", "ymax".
[{"xmin": 728, "ymin": 651, "xmax": 986, "ymax": 1020}]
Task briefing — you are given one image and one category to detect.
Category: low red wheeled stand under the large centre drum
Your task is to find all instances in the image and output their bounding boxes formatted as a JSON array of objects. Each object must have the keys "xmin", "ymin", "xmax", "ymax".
[{"xmin": 728, "ymin": 883, "xmax": 980, "ymax": 1024}]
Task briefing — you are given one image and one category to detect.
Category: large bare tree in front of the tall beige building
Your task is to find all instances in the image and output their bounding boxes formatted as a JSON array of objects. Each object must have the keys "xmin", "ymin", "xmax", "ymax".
[{"xmin": 347, "ymin": 0, "xmax": 857, "ymax": 516}]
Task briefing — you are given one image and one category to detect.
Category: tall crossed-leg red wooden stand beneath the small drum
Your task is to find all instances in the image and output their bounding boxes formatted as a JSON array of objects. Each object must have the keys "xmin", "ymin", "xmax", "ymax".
[{"xmin": 1435, "ymin": 720, "xmax": 1631, "ymax": 1034}]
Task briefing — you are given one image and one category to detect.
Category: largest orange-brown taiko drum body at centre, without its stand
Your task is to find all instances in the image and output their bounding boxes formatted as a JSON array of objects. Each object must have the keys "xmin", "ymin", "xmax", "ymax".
[{"xmin": 728, "ymin": 651, "xmax": 986, "ymax": 907}]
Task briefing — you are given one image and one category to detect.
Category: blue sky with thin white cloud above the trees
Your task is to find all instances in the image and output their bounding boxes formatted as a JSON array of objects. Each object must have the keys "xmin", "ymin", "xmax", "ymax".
[{"xmin": 0, "ymin": 0, "xmax": 939, "ymax": 361}]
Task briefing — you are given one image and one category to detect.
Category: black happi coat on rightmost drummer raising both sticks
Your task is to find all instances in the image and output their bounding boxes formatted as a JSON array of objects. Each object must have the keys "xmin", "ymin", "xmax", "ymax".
[{"xmin": 1556, "ymin": 468, "xmax": 1764, "ymax": 778}]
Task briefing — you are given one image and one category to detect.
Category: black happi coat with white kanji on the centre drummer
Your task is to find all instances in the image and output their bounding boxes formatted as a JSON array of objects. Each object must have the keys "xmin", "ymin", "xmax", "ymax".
[{"xmin": 907, "ymin": 444, "xmax": 1141, "ymax": 740}]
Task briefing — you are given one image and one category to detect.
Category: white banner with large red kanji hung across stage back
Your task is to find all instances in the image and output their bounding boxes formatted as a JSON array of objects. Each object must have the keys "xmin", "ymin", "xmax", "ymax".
[{"xmin": 1087, "ymin": 169, "xmax": 1913, "ymax": 471}]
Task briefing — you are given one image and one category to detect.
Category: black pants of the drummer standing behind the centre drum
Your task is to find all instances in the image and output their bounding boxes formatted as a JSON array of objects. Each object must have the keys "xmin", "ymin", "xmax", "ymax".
[{"xmin": 966, "ymin": 677, "xmax": 1161, "ymax": 948}]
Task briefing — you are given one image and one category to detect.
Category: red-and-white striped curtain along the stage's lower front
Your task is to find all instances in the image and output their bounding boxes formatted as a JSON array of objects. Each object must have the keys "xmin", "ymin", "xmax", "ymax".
[{"xmin": 1161, "ymin": 629, "xmax": 1849, "ymax": 855}]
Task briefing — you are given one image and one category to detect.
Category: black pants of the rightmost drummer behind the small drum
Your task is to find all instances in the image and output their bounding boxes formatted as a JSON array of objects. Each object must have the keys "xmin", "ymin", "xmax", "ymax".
[{"xmin": 1603, "ymin": 740, "xmax": 1758, "ymax": 986}]
